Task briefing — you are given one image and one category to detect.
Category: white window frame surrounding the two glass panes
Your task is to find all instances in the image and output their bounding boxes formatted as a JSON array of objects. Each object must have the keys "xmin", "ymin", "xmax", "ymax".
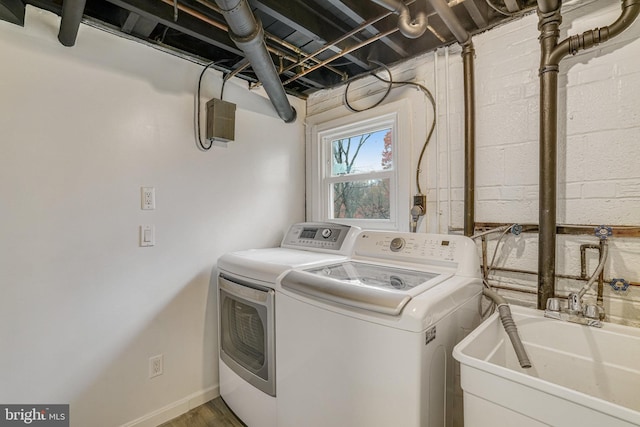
[{"xmin": 307, "ymin": 100, "xmax": 412, "ymax": 231}]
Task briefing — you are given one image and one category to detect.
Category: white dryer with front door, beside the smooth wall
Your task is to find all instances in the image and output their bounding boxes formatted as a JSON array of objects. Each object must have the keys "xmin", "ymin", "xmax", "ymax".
[{"xmin": 218, "ymin": 222, "xmax": 359, "ymax": 427}]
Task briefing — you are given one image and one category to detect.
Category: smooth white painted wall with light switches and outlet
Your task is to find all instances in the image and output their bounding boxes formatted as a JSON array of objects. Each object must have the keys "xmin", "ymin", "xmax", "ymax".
[{"xmin": 0, "ymin": 7, "xmax": 305, "ymax": 427}]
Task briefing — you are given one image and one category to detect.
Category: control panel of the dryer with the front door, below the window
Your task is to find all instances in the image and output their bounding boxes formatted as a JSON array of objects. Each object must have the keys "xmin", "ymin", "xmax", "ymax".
[{"xmin": 281, "ymin": 222, "xmax": 360, "ymax": 252}]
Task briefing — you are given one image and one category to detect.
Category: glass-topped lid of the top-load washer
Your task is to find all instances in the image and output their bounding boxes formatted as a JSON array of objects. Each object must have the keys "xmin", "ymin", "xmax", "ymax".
[{"xmin": 280, "ymin": 261, "xmax": 451, "ymax": 316}]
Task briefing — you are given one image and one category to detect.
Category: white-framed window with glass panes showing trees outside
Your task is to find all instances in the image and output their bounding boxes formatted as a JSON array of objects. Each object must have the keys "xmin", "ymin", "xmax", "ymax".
[{"xmin": 308, "ymin": 101, "xmax": 410, "ymax": 230}]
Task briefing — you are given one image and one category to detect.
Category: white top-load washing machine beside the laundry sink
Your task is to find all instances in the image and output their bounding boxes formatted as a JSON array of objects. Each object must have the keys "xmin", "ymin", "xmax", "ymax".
[{"xmin": 276, "ymin": 231, "xmax": 482, "ymax": 427}]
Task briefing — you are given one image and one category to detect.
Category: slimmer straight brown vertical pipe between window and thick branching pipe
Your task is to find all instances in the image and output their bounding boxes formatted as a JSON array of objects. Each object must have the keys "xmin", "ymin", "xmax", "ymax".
[{"xmin": 462, "ymin": 40, "xmax": 476, "ymax": 236}]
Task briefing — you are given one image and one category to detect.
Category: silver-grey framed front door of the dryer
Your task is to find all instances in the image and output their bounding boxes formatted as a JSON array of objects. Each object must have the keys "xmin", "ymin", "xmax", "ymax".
[{"xmin": 218, "ymin": 274, "xmax": 276, "ymax": 396}]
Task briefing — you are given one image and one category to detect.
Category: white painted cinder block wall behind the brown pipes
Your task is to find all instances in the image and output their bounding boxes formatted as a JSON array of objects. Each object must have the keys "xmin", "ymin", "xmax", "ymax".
[{"xmin": 307, "ymin": 0, "xmax": 640, "ymax": 326}]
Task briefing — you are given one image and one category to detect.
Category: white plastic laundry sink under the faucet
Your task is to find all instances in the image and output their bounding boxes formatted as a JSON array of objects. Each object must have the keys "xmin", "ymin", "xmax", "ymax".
[{"xmin": 453, "ymin": 305, "xmax": 640, "ymax": 427}]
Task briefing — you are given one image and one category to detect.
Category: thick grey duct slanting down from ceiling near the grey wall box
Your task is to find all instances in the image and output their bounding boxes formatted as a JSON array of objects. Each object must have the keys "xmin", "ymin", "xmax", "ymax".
[{"xmin": 216, "ymin": 0, "xmax": 296, "ymax": 123}]
